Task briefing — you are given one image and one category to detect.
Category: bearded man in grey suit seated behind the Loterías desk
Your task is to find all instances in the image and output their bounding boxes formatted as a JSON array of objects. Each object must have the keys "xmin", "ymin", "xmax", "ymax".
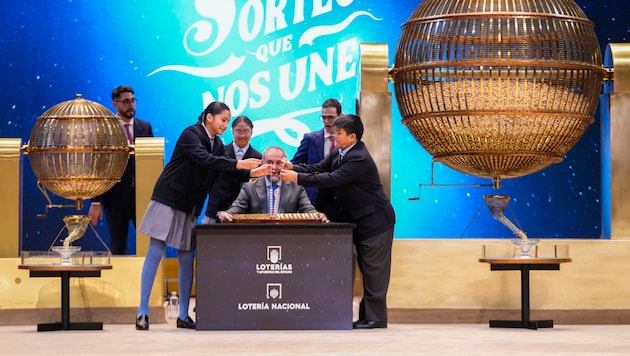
[{"xmin": 217, "ymin": 146, "xmax": 328, "ymax": 222}]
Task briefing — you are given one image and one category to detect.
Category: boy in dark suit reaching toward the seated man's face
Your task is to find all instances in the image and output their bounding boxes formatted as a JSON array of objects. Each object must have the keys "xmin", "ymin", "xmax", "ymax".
[{"xmin": 280, "ymin": 115, "xmax": 395, "ymax": 329}]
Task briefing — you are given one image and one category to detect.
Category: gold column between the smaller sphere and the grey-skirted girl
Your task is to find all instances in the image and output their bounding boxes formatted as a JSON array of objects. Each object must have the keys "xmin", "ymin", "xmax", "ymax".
[{"xmin": 134, "ymin": 137, "xmax": 164, "ymax": 256}]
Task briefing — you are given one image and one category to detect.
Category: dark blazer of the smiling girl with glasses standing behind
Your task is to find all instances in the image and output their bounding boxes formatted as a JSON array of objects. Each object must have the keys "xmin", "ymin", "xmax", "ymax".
[{"xmin": 206, "ymin": 143, "xmax": 262, "ymax": 219}]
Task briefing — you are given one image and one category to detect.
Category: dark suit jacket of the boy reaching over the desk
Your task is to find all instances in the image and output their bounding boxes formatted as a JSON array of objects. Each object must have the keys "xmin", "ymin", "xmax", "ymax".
[{"xmin": 293, "ymin": 141, "xmax": 395, "ymax": 238}]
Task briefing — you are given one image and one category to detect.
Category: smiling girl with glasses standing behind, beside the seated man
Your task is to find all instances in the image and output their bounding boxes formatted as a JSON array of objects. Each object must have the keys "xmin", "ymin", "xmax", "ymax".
[{"xmin": 203, "ymin": 116, "xmax": 262, "ymax": 224}]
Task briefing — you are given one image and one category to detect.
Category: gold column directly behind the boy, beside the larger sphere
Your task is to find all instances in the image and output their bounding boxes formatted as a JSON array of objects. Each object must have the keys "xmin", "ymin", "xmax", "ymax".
[{"xmin": 357, "ymin": 43, "xmax": 392, "ymax": 195}]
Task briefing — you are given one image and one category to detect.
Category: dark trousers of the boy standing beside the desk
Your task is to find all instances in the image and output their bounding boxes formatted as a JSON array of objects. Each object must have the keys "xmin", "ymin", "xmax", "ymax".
[{"xmin": 354, "ymin": 228, "xmax": 394, "ymax": 323}]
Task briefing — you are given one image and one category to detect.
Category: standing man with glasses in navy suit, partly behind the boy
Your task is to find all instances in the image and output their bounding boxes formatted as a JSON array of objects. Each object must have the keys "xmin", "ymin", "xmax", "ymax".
[{"xmin": 291, "ymin": 98, "xmax": 341, "ymax": 221}]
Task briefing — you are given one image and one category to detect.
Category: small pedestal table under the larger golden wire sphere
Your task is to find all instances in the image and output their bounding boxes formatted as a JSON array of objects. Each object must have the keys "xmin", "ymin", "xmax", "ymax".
[{"xmin": 479, "ymin": 257, "xmax": 571, "ymax": 330}]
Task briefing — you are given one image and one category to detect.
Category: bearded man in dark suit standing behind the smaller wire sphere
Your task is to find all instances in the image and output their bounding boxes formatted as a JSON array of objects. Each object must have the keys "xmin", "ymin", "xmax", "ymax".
[{"xmin": 88, "ymin": 85, "xmax": 153, "ymax": 255}]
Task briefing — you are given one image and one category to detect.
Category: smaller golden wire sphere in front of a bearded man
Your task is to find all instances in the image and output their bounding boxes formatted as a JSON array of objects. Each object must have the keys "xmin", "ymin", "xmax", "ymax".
[{"xmin": 24, "ymin": 95, "xmax": 130, "ymax": 206}]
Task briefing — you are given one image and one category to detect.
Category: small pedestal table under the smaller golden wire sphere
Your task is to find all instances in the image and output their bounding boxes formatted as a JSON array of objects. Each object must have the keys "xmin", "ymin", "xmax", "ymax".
[{"xmin": 18, "ymin": 265, "xmax": 112, "ymax": 331}]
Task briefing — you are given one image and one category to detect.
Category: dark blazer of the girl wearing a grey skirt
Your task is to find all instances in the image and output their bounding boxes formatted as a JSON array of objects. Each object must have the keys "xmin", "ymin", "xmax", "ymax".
[{"xmin": 151, "ymin": 122, "xmax": 249, "ymax": 216}]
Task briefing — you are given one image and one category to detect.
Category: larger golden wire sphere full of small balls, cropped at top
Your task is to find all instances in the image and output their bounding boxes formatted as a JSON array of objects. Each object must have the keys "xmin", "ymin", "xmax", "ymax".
[{"xmin": 390, "ymin": 0, "xmax": 604, "ymax": 185}]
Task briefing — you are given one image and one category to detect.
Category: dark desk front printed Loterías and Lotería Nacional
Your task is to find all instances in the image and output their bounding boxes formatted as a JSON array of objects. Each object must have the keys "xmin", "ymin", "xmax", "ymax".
[{"xmin": 196, "ymin": 223, "xmax": 354, "ymax": 330}]
